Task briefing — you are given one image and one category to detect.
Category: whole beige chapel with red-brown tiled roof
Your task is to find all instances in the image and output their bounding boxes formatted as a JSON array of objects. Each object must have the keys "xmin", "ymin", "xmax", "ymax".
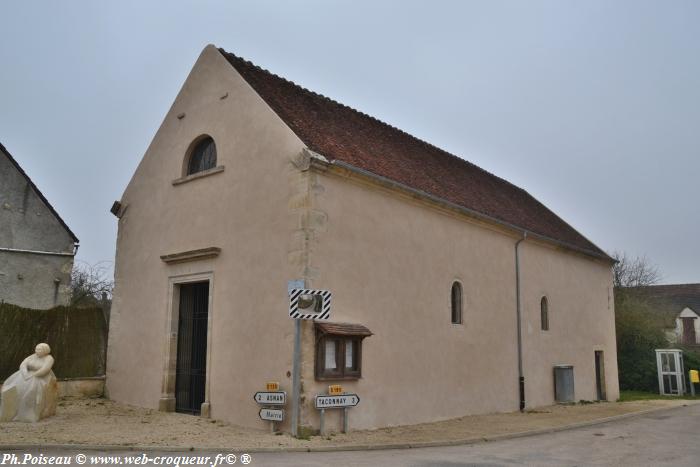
[{"xmin": 107, "ymin": 45, "xmax": 619, "ymax": 430}]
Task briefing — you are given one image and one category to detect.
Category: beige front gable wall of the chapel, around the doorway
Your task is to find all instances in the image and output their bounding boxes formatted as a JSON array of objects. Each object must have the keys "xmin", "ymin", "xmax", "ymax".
[{"xmin": 107, "ymin": 46, "xmax": 307, "ymax": 434}]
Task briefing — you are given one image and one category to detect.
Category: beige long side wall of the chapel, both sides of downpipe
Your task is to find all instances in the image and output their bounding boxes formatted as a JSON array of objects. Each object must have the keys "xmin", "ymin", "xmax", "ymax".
[{"xmin": 304, "ymin": 170, "xmax": 618, "ymax": 429}]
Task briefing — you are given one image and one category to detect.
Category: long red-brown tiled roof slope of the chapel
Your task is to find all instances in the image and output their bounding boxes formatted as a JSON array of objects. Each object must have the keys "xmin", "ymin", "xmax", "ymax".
[{"xmin": 219, "ymin": 49, "xmax": 610, "ymax": 259}]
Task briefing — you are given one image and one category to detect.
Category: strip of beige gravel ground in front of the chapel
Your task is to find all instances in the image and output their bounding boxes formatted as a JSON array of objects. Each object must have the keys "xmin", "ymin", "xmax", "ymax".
[{"xmin": 0, "ymin": 399, "xmax": 693, "ymax": 449}]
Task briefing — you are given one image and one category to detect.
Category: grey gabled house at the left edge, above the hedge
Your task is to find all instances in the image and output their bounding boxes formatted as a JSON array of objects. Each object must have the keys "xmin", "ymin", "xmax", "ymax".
[{"xmin": 0, "ymin": 144, "xmax": 78, "ymax": 309}]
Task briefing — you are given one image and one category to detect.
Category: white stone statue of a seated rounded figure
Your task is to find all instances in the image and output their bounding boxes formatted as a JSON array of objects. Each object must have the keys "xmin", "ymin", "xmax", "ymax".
[{"xmin": 0, "ymin": 343, "xmax": 58, "ymax": 422}]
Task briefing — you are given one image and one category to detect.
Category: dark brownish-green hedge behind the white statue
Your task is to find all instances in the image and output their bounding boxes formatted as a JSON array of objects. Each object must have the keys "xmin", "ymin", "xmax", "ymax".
[{"xmin": 0, "ymin": 303, "xmax": 107, "ymax": 381}]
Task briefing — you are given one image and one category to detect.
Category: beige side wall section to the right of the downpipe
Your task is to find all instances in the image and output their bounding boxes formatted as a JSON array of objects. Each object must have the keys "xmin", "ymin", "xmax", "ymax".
[{"xmin": 521, "ymin": 242, "xmax": 619, "ymax": 407}]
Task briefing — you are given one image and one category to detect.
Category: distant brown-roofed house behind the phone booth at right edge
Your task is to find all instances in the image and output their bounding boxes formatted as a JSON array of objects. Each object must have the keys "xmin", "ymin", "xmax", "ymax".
[{"xmin": 624, "ymin": 284, "xmax": 700, "ymax": 345}]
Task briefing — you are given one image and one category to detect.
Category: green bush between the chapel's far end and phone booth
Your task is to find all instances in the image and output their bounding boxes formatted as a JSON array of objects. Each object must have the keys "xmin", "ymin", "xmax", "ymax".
[{"xmin": 615, "ymin": 296, "xmax": 668, "ymax": 392}]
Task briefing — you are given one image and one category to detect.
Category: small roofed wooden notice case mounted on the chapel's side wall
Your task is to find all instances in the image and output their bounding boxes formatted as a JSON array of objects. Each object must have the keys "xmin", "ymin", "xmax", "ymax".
[{"xmin": 315, "ymin": 323, "xmax": 372, "ymax": 381}]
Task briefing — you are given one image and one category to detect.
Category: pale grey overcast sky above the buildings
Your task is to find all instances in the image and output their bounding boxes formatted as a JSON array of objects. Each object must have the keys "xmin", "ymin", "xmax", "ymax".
[{"xmin": 0, "ymin": 0, "xmax": 700, "ymax": 283}]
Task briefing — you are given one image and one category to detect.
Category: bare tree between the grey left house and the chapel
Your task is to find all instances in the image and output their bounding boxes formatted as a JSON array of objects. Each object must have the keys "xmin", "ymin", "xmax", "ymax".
[{"xmin": 71, "ymin": 261, "xmax": 114, "ymax": 306}]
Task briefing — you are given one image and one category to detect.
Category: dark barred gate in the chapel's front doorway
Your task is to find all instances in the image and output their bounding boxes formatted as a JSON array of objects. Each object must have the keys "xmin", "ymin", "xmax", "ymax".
[{"xmin": 175, "ymin": 282, "xmax": 209, "ymax": 415}]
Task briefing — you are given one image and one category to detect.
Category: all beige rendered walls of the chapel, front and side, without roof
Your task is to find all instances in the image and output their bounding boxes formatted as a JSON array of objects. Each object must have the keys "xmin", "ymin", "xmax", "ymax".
[{"xmin": 107, "ymin": 46, "xmax": 617, "ymax": 436}]
